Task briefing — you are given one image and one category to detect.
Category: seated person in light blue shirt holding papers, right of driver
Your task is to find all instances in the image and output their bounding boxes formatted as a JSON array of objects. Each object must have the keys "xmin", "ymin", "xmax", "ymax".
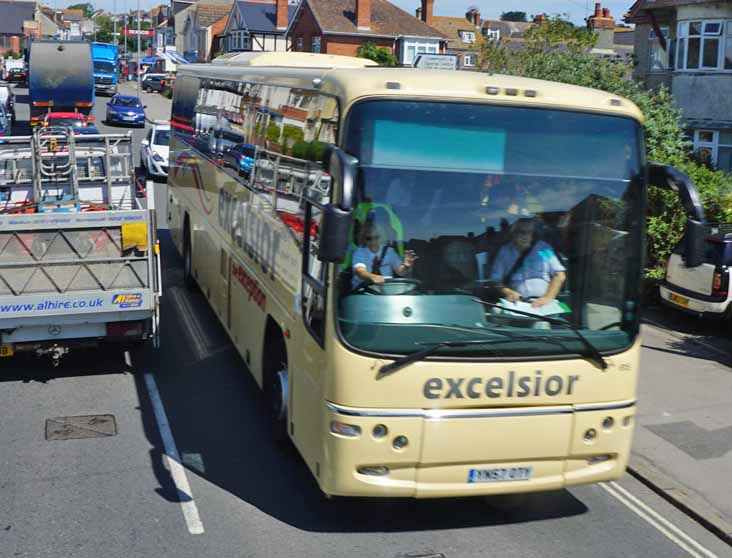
[{"xmin": 491, "ymin": 218, "xmax": 567, "ymax": 308}]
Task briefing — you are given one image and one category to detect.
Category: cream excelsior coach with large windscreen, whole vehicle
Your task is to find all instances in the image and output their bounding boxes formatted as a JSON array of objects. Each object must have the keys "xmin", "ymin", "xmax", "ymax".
[{"xmin": 168, "ymin": 53, "xmax": 703, "ymax": 498}]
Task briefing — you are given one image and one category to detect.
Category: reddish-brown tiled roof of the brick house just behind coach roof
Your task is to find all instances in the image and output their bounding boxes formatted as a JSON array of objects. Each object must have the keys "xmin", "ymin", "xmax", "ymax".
[{"xmin": 304, "ymin": 0, "xmax": 446, "ymax": 39}]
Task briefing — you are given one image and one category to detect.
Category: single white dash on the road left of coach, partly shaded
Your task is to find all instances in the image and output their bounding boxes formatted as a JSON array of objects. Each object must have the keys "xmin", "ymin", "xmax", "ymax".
[{"xmin": 145, "ymin": 372, "xmax": 204, "ymax": 535}]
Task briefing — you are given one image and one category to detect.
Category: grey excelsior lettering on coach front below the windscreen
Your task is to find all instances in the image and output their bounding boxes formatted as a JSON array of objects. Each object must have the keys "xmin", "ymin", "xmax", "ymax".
[{"xmin": 422, "ymin": 370, "xmax": 579, "ymax": 399}]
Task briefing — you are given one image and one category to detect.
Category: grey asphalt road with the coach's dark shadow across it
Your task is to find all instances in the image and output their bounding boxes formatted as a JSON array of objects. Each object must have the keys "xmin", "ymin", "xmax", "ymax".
[{"xmin": 0, "ymin": 81, "xmax": 732, "ymax": 558}]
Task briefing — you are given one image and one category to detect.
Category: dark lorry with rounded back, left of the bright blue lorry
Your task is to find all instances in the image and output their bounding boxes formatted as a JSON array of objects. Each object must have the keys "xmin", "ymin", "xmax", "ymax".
[{"xmin": 27, "ymin": 40, "xmax": 94, "ymax": 126}]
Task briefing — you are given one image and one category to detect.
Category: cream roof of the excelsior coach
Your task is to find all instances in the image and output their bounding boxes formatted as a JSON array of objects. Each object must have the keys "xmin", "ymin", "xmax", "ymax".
[{"xmin": 186, "ymin": 52, "xmax": 643, "ymax": 122}]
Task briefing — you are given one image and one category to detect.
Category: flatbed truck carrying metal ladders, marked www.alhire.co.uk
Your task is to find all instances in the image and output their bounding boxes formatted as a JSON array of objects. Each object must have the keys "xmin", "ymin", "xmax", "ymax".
[{"xmin": 0, "ymin": 128, "xmax": 162, "ymax": 363}]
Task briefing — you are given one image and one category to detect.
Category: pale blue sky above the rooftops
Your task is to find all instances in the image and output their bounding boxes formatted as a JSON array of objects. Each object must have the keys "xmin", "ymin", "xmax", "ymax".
[{"xmin": 44, "ymin": 0, "xmax": 633, "ymax": 24}]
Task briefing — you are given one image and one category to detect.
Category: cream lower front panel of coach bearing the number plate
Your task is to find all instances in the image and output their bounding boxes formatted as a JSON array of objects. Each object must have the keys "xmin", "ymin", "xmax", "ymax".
[{"xmin": 416, "ymin": 406, "xmax": 573, "ymax": 497}]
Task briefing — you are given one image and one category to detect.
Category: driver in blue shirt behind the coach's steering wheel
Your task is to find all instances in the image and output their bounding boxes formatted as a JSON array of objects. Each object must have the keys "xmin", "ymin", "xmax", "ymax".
[{"xmin": 352, "ymin": 221, "xmax": 417, "ymax": 288}]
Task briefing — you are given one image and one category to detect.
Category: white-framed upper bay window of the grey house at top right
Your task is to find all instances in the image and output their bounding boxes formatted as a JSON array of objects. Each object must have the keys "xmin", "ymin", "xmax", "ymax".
[{"xmin": 676, "ymin": 20, "xmax": 732, "ymax": 71}]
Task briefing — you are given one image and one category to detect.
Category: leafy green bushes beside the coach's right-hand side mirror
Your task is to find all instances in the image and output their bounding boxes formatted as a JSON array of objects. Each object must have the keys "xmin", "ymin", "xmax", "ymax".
[{"xmin": 480, "ymin": 18, "xmax": 732, "ymax": 277}]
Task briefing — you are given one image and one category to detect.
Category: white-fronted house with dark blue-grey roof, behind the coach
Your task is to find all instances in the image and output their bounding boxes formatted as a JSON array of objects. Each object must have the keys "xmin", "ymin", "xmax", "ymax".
[{"xmin": 222, "ymin": 0, "xmax": 296, "ymax": 52}]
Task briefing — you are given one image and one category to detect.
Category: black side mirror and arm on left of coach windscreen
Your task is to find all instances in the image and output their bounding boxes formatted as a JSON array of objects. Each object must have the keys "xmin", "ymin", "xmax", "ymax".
[{"xmin": 318, "ymin": 146, "xmax": 358, "ymax": 263}]
